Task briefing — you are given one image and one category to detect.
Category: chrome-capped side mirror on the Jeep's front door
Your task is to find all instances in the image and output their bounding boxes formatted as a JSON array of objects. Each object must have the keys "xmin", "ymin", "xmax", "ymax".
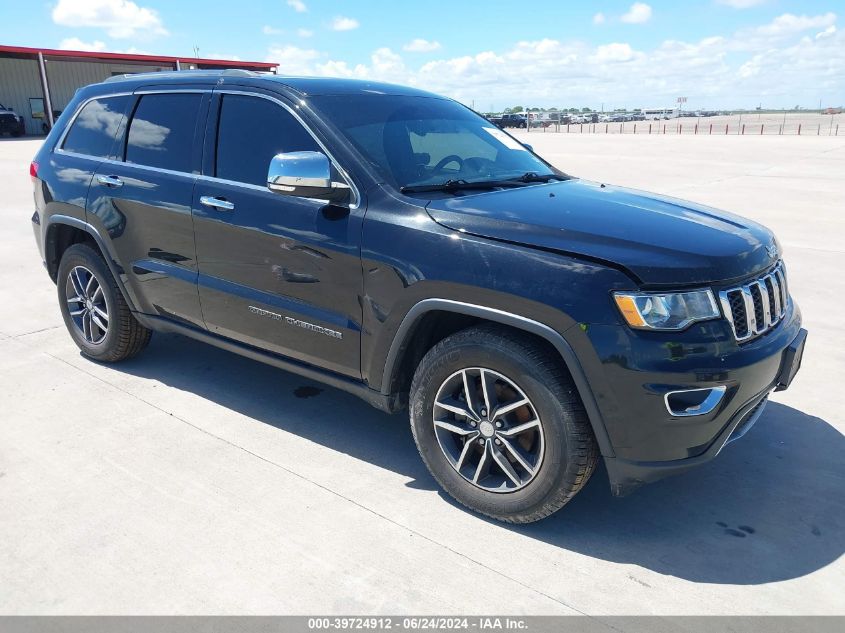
[{"xmin": 267, "ymin": 152, "xmax": 349, "ymax": 202}]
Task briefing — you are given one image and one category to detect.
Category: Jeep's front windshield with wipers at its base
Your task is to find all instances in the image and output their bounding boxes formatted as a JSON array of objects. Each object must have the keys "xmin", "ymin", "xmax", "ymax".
[{"xmin": 312, "ymin": 95, "xmax": 559, "ymax": 189}]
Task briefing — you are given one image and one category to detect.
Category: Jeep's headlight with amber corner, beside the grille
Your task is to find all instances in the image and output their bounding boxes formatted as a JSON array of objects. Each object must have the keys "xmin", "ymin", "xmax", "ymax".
[{"xmin": 613, "ymin": 289, "xmax": 719, "ymax": 330}]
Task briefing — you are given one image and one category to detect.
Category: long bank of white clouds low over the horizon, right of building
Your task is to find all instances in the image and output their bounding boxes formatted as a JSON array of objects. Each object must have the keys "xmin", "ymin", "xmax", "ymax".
[{"xmin": 268, "ymin": 14, "xmax": 845, "ymax": 109}]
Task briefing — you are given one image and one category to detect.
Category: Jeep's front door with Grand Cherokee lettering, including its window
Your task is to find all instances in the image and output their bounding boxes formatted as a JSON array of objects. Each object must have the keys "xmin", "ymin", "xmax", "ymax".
[{"xmin": 193, "ymin": 91, "xmax": 363, "ymax": 378}]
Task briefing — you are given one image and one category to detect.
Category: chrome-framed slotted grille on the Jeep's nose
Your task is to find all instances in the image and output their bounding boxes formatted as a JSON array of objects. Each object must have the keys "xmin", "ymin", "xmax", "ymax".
[{"xmin": 719, "ymin": 262, "xmax": 789, "ymax": 341}]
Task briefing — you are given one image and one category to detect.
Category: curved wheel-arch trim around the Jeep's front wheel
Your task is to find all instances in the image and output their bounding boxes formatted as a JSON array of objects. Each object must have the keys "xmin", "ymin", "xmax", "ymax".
[{"xmin": 381, "ymin": 299, "xmax": 615, "ymax": 457}]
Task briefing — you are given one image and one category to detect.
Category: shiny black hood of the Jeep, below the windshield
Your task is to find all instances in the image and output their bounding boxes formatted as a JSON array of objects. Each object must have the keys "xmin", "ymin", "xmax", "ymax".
[{"xmin": 426, "ymin": 179, "xmax": 780, "ymax": 285}]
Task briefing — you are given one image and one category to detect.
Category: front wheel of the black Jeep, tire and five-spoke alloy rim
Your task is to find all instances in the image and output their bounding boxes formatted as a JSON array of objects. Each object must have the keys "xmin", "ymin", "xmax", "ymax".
[{"xmin": 409, "ymin": 325, "xmax": 598, "ymax": 523}]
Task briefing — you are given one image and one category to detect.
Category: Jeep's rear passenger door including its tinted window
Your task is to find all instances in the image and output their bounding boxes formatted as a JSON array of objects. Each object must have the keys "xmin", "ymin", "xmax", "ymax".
[{"xmin": 88, "ymin": 90, "xmax": 210, "ymax": 327}]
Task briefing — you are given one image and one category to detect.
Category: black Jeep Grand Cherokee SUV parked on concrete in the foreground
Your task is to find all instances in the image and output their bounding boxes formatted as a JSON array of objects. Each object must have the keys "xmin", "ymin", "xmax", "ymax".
[{"xmin": 31, "ymin": 71, "xmax": 806, "ymax": 522}]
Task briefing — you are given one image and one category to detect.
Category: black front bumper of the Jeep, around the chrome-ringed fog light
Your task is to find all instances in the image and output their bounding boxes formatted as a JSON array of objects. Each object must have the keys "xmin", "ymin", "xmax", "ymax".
[{"xmin": 579, "ymin": 301, "xmax": 806, "ymax": 495}]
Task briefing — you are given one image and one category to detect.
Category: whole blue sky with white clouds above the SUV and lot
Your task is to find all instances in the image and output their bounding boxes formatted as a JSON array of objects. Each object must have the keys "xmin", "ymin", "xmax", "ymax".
[{"xmin": 0, "ymin": 0, "xmax": 845, "ymax": 110}]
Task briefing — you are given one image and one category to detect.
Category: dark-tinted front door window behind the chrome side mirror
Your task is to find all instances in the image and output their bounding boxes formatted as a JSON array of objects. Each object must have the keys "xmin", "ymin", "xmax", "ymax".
[{"xmin": 215, "ymin": 95, "xmax": 321, "ymax": 187}]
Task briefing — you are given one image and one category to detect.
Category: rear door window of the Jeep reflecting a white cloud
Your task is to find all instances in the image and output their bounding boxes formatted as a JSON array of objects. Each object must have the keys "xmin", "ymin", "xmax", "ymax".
[{"xmin": 126, "ymin": 94, "xmax": 202, "ymax": 172}]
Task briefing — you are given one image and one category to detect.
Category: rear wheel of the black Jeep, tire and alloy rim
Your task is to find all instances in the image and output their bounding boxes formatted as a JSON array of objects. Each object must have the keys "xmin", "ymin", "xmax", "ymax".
[{"xmin": 56, "ymin": 244, "xmax": 152, "ymax": 363}]
